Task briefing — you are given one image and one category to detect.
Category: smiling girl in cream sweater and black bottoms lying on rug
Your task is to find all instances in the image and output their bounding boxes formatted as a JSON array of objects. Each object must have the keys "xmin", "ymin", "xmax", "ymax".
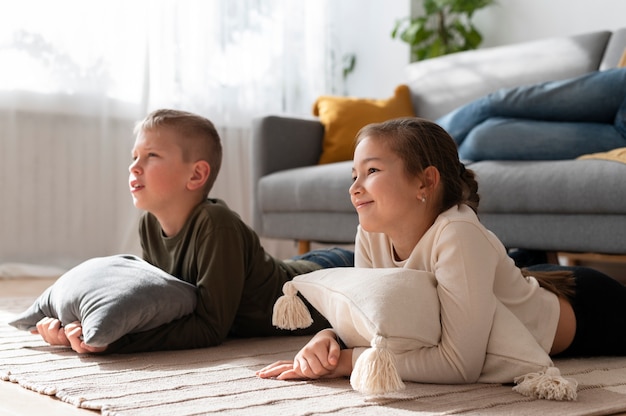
[{"xmin": 258, "ymin": 118, "xmax": 626, "ymax": 383}]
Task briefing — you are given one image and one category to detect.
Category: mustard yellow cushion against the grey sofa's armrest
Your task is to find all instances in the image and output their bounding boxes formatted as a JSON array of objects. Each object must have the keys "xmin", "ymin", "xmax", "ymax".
[{"xmin": 313, "ymin": 85, "xmax": 415, "ymax": 164}]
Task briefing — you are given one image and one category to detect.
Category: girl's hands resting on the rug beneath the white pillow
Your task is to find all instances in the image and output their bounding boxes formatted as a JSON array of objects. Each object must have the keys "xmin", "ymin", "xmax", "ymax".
[{"xmin": 257, "ymin": 330, "xmax": 352, "ymax": 380}]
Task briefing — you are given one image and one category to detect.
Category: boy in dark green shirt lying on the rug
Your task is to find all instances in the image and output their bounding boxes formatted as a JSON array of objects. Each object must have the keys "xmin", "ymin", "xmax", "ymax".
[{"xmin": 37, "ymin": 109, "xmax": 354, "ymax": 353}]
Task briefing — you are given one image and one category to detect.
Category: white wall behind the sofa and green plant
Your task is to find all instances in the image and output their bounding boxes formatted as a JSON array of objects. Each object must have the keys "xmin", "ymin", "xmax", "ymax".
[{"xmin": 342, "ymin": 0, "xmax": 626, "ymax": 98}]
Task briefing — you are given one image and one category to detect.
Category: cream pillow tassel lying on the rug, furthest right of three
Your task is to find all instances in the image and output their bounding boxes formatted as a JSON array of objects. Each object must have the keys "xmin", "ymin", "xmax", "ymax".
[{"xmin": 513, "ymin": 367, "xmax": 578, "ymax": 400}]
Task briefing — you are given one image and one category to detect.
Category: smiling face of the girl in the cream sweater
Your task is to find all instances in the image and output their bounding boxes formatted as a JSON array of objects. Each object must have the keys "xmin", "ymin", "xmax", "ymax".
[{"xmin": 350, "ymin": 136, "xmax": 425, "ymax": 240}]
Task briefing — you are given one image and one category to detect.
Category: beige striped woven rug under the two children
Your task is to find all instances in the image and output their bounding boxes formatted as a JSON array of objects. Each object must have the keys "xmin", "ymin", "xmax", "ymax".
[{"xmin": 0, "ymin": 298, "xmax": 626, "ymax": 416}]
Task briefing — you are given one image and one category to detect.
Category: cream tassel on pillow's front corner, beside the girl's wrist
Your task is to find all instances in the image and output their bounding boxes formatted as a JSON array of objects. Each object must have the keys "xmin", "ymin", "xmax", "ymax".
[{"xmin": 350, "ymin": 335, "xmax": 405, "ymax": 396}]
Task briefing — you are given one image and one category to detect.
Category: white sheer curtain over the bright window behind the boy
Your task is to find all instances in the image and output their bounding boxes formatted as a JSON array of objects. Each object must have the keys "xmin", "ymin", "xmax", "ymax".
[{"xmin": 0, "ymin": 0, "xmax": 340, "ymax": 268}]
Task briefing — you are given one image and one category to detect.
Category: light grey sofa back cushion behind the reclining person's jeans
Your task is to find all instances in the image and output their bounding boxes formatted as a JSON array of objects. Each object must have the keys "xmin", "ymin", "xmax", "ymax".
[{"xmin": 406, "ymin": 31, "xmax": 608, "ymax": 120}]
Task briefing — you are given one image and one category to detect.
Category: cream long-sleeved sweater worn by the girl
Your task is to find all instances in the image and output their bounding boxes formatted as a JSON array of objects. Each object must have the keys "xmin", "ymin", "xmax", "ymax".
[{"xmin": 353, "ymin": 205, "xmax": 559, "ymax": 383}]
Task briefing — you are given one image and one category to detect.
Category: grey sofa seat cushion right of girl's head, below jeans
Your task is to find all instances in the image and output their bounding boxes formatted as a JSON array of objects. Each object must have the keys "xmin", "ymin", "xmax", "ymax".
[{"xmin": 468, "ymin": 160, "xmax": 626, "ymax": 215}]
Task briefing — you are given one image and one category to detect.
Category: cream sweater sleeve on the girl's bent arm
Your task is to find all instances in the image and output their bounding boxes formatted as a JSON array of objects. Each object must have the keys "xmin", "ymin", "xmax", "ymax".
[{"xmin": 353, "ymin": 222, "xmax": 498, "ymax": 384}]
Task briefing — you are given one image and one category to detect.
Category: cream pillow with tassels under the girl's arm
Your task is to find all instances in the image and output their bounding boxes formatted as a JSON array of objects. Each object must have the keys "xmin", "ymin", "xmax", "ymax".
[{"xmin": 273, "ymin": 268, "xmax": 576, "ymax": 400}]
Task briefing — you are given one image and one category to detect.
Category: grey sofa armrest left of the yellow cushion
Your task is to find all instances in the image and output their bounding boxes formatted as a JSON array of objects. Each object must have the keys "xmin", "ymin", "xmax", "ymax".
[{"xmin": 250, "ymin": 115, "xmax": 324, "ymax": 231}]
